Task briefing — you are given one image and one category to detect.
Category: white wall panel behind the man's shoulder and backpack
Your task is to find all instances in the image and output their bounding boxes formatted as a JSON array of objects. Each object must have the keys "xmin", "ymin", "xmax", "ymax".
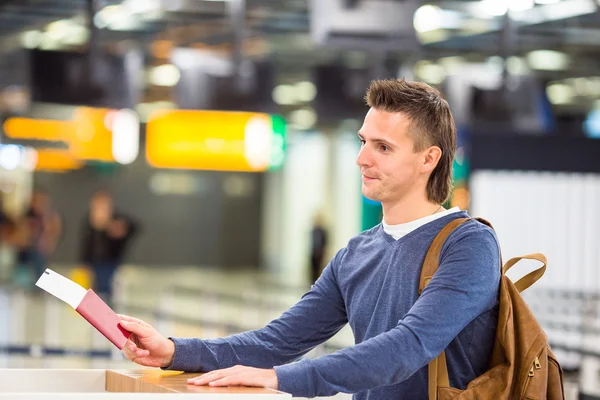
[{"xmin": 470, "ymin": 171, "xmax": 600, "ymax": 293}]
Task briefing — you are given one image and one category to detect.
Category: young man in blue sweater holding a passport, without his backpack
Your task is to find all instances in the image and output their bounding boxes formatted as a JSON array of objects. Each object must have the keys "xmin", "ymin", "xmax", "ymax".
[{"xmin": 122, "ymin": 80, "xmax": 500, "ymax": 400}]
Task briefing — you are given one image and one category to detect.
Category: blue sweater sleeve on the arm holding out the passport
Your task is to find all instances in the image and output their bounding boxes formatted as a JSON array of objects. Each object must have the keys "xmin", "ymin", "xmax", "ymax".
[{"xmin": 168, "ymin": 253, "xmax": 347, "ymax": 372}]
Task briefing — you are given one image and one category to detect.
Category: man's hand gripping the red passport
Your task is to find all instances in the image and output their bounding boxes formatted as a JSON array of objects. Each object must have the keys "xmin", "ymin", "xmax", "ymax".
[{"xmin": 119, "ymin": 315, "xmax": 175, "ymax": 368}]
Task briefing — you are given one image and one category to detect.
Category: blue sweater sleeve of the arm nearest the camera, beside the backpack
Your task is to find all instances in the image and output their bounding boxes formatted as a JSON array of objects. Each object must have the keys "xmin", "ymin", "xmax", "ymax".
[{"xmin": 275, "ymin": 228, "xmax": 500, "ymax": 397}]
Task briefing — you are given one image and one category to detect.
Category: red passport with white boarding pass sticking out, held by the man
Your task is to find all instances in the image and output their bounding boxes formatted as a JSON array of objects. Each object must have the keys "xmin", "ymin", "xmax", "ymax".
[{"xmin": 35, "ymin": 268, "xmax": 129, "ymax": 350}]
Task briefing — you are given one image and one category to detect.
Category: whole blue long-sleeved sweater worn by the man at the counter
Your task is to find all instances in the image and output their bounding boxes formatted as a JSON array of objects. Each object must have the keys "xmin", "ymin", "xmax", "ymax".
[{"xmin": 169, "ymin": 212, "xmax": 500, "ymax": 400}]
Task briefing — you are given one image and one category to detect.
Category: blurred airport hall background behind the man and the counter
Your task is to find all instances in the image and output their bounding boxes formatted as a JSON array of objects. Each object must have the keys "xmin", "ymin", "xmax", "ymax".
[{"xmin": 0, "ymin": 0, "xmax": 600, "ymax": 399}]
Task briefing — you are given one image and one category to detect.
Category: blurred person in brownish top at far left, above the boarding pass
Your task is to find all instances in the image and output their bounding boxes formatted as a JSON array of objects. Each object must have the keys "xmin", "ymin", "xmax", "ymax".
[{"xmin": 14, "ymin": 189, "xmax": 62, "ymax": 287}]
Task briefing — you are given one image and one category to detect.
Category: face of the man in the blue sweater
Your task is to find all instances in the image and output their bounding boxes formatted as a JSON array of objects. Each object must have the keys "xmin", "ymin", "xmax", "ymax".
[{"xmin": 356, "ymin": 108, "xmax": 427, "ymax": 203}]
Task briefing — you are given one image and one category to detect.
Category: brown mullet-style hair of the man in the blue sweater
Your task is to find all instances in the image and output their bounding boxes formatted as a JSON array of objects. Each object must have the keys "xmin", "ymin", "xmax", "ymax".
[{"xmin": 365, "ymin": 79, "xmax": 456, "ymax": 204}]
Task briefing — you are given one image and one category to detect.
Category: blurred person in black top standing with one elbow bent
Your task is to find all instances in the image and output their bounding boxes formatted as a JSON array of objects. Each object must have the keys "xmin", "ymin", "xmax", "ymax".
[{"xmin": 80, "ymin": 190, "xmax": 138, "ymax": 302}]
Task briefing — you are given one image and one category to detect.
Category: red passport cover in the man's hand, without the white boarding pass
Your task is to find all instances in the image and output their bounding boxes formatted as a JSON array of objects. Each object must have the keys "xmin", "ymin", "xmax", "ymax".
[{"xmin": 75, "ymin": 289, "xmax": 129, "ymax": 350}]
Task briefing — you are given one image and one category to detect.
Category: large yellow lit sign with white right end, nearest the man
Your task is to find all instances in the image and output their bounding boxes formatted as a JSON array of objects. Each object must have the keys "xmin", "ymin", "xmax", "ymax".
[{"xmin": 146, "ymin": 110, "xmax": 273, "ymax": 171}]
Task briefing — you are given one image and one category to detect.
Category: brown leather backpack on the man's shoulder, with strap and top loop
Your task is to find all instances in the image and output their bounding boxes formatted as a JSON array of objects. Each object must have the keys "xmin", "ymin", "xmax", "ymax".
[{"xmin": 419, "ymin": 218, "xmax": 565, "ymax": 400}]
